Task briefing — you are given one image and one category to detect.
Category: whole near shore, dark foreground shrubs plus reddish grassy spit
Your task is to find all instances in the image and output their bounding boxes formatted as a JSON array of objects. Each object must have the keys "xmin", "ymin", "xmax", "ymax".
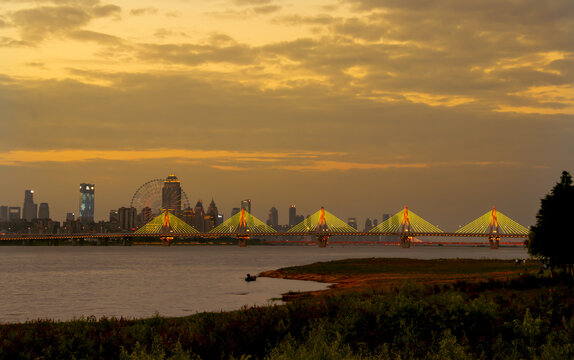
[{"xmin": 0, "ymin": 258, "xmax": 574, "ymax": 360}]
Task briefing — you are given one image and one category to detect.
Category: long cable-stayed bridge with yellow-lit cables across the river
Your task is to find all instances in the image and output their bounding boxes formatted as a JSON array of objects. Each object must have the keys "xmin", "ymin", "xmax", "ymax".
[{"xmin": 0, "ymin": 206, "xmax": 529, "ymax": 249}]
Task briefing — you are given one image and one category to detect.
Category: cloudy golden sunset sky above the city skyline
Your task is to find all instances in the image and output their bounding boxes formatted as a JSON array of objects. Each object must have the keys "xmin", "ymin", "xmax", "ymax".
[{"xmin": 0, "ymin": 0, "xmax": 574, "ymax": 231}]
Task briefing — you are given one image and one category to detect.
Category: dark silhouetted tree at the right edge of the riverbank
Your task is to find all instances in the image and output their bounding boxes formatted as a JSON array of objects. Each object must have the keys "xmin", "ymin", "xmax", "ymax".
[{"xmin": 528, "ymin": 171, "xmax": 574, "ymax": 274}]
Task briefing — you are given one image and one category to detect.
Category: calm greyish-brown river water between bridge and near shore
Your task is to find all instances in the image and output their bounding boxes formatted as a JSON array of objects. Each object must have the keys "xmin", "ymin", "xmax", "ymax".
[{"xmin": 0, "ymin": 246, "xmax": 528, "ymax": 322}]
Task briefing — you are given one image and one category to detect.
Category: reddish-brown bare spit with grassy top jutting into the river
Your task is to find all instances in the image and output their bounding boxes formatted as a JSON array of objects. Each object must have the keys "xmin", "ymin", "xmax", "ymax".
[{"xmin": 259, "ymin": 258, "xmax": 541, "ymax": 301}]
